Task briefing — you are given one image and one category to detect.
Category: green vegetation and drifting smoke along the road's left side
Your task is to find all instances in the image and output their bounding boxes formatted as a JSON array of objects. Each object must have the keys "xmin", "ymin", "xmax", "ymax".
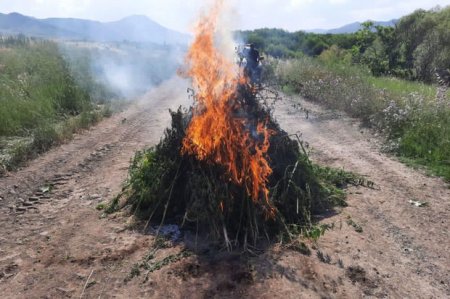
[{"xmin": 0, "ymin": 36, "xmax": 181, "ymax": 175}]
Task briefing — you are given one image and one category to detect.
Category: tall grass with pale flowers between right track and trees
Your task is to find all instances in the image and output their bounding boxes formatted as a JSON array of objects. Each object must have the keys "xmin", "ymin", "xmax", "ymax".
[{"xmin": 275, "ymin": 53, "xmax": 450, "ymax": 180}]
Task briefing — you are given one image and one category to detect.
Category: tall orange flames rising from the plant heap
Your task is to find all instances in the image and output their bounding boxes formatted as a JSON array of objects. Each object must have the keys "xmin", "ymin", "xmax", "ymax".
[{"xmin": 182, "ymin": 1, "xmax": 275, "ymax": 218}]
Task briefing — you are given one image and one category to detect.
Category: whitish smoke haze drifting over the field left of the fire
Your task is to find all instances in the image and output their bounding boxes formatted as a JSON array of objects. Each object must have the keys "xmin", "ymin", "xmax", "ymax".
[{"xmin": 61, "ymin": 42, "xmax": 186, "ymax": 99}]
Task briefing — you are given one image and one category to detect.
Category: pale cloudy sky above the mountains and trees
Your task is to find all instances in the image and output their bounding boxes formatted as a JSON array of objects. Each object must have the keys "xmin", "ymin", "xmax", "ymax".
[{"xmin": 0, "ymin": 0, "xmax": 450, "ymax": 32}]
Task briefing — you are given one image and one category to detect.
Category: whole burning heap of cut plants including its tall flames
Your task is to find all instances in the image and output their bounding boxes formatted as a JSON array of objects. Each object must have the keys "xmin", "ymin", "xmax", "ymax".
[{"xmin": 110, "ymin": 1, "xmax": 352, "ymax": 248}]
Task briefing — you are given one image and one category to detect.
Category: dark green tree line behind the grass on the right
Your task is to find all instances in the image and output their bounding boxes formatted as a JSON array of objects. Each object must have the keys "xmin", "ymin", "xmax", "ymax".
[{"xmin": 236, "ymin": 6, "xmax": 450, "ymax": 83}]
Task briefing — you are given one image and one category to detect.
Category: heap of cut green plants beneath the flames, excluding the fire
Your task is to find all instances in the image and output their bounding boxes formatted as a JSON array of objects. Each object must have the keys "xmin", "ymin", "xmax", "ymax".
[{"xmin": 109, "ymin": 85, "xmax": 352, "ymax": 248}]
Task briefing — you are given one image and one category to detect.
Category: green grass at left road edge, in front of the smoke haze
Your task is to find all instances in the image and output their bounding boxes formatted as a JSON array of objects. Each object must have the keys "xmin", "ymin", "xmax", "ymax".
[{"xmin": 0, "ymin": 36, "xmax": 121, "ymax": 171}]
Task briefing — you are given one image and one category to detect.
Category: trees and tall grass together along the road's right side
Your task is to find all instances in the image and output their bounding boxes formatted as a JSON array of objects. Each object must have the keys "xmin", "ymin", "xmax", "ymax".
[{"xmin": 241, "ymin": 7, "xmax": 450, "ymax": 180}]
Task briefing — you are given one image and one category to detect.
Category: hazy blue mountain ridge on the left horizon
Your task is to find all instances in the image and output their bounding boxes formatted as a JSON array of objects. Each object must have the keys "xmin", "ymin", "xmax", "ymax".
[{"xmin": 0, "ymin": 13, "xmax": 190, "ymax": 44}]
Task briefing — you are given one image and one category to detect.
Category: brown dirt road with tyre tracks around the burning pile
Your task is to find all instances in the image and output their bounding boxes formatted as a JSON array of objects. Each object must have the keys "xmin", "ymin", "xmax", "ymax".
[{"xmin": 0, "ymin": 81, "xmax": 450, "ymax": 298}]
